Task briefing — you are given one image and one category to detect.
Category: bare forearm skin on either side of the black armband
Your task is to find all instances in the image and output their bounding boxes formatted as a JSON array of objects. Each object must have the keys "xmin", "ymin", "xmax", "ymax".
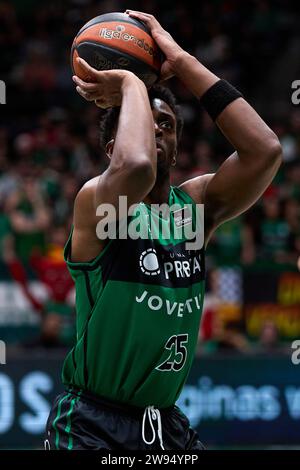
[{"xmin": 175, "ymin": 53, "xmax": 280, "ymax": 163}]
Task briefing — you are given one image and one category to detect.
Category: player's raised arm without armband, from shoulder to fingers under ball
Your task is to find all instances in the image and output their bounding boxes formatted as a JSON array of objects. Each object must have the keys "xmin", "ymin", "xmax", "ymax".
[{"xmin": 72, "ymin": 59, "xmax": 157, "ymax": 261}]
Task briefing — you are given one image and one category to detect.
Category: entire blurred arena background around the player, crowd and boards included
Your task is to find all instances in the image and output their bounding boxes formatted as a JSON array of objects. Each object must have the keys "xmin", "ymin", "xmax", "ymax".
[{"xmin": 0, "ymin": 0, "xmax": 300, "ymax": 449}]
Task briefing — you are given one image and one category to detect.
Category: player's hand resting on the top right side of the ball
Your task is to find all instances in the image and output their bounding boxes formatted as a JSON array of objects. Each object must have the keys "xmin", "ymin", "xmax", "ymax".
[{"xmin": 125, "ymin": 10, "xmax": 185, "ymax": 80}]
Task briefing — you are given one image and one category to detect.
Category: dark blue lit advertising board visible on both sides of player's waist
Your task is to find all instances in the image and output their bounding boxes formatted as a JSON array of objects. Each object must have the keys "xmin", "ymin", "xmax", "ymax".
[{"xmin": 0, "ymin": 352, "xmax": 300, "ymax": 449}]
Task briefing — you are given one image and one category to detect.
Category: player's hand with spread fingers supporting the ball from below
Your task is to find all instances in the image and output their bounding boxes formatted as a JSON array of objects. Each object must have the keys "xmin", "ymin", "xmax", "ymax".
[{"xmin": 72, "ymin": 57, "xmax": 142, "ymax": 109}]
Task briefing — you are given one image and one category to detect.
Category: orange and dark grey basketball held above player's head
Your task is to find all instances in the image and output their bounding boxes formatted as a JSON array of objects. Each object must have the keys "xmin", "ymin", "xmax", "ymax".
[{"xmin": 71, "ymin": 13, "xmax": 162, "ymax": 88}]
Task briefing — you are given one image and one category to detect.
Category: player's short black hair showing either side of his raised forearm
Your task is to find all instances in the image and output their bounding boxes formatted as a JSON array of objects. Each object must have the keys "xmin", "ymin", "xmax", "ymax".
[{"xmin": 100, "ymin": 85, "xmax": 183, "ymax": 149}]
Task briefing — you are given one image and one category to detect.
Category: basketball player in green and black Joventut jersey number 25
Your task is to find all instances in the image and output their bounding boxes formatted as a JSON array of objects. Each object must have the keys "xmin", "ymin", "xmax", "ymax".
[{"xmin": 46, "ymin": 11, "xmax": 281, "ymax": 450}]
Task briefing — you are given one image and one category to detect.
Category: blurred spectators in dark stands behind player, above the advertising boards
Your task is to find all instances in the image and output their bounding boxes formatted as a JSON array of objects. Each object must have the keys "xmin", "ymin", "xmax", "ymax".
[{"xmin": 0, "ymin": 0, "xmax": 300, "ymax": 352}]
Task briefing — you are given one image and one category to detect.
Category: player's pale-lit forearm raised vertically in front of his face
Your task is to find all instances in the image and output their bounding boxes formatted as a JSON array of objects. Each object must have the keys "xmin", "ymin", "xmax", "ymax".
[{"xmin": 112, "ymin": 77, "xmax": 156, "ymax": 172}]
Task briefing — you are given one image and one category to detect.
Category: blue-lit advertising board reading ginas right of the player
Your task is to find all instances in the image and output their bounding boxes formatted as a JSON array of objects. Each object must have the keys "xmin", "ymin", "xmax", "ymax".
[{"xmin": 178, "ymin": 354, "xmax": 300, "ymax": 446}]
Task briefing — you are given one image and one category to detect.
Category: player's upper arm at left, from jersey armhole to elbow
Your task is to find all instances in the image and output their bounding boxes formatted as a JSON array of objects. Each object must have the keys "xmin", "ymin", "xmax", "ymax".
[{"xmin": 72, "ymin": 162, "xmax": 152, "ymax": 262}]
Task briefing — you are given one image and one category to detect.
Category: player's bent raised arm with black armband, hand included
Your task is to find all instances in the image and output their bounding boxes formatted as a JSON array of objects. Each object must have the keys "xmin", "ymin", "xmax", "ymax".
[{"xmin": 128, "ymin": 11, "xmax": 281, "ymax": 244}]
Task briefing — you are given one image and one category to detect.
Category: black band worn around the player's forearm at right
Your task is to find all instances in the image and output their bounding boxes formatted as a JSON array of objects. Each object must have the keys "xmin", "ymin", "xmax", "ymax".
[{"xmin": 200, "ymin": 80, "xmax": 243, "ymax": 121}]
